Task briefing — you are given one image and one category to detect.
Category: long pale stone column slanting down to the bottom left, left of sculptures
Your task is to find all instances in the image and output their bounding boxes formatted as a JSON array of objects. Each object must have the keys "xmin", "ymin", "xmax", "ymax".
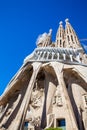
[{"xmin": 8, "ymin": 63, "xmax": 41, "ymax": 130}]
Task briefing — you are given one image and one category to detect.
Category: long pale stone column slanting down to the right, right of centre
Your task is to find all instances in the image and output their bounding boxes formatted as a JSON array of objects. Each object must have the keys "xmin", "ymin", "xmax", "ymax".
[{"xmin": 51, "ymin": 62, "xmax": 78, "ymax": 130}]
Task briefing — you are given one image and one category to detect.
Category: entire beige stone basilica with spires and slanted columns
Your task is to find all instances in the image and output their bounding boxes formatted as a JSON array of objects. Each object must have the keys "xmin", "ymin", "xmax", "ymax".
[{"xmin": 0, "ymin": 19, "xmax": 87, "ymax": 130}]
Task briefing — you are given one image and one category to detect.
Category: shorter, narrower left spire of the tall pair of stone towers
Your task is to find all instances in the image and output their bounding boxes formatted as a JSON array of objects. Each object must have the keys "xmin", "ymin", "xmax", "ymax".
[{"xmin": 55, "ymin": 21, "xmax": 64, "ymax": 47}]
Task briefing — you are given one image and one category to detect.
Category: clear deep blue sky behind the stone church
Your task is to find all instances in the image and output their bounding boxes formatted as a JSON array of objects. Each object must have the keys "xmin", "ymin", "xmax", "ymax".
[{"xmin": 0, "ymin": 0, "xmax": 87, "ymax": 95}]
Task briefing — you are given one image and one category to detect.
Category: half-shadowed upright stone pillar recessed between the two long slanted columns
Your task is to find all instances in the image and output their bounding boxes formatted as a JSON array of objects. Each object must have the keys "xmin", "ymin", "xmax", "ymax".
[{"xmin": 41, "ymin": 68, "xmax": 56, "ymax": 128}]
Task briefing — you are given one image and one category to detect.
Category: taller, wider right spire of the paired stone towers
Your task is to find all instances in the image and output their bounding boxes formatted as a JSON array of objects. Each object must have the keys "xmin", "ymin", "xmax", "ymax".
[{"xmin": 65, "ymin": 19, "xmax": 80, "ymax": 48}]
